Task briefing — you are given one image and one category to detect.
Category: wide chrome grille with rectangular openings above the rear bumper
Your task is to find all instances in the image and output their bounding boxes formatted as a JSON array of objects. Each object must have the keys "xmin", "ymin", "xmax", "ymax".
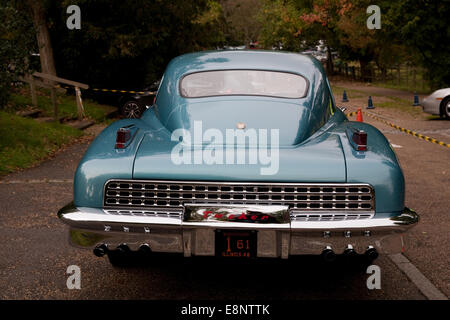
[{"xmin": 104, "ymin": 180, "xmax": 375, "ymax": 212}]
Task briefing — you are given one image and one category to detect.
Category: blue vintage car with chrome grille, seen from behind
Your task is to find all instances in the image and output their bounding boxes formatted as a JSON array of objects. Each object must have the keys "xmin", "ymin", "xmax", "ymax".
[{"xmin": 58, "ymin": 50, "xmax": 418, "ymax": 264}]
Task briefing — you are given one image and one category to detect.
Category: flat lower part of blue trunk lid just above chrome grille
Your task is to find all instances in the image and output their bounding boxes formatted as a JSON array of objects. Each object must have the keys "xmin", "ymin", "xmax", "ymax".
[{"xmin": 133, "ymin": 131, "xmax": 346, "ymax": 182}]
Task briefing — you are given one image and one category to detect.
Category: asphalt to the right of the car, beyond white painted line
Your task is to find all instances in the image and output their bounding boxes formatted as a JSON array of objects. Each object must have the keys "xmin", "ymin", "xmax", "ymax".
[{"xmin": 336, "ymin": 83, "xmax": 450, "ymax": 297}]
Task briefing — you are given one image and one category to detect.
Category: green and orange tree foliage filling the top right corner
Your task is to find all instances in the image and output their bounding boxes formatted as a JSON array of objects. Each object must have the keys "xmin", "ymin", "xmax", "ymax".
[{"xmin": 260, "ymin": 0, "xmax": 450, "ymax": 88}]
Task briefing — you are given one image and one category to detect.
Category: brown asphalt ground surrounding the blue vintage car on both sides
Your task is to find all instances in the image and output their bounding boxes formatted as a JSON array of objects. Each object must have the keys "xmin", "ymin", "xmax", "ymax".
[{"xmin": 0, "ymin": 85, "xmax": 450, "ymax": 300}]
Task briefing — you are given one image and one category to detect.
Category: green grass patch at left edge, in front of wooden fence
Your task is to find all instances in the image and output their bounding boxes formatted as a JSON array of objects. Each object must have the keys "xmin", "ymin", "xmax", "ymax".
[{"xmin": 0, "ymin": 111, "xmax": 83, "ymax": 176}]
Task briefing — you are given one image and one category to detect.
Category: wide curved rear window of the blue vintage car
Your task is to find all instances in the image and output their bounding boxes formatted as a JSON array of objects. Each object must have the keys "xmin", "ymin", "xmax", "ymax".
[{"xmin": 180, "ymin": 70, "xmax": 307, "ymax": 98}]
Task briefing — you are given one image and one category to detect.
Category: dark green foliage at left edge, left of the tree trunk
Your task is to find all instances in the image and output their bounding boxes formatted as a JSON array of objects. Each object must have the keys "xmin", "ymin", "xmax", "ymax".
[{"xmin": 0, "ymin": 0, "xmax": 37, "ymax": 109}]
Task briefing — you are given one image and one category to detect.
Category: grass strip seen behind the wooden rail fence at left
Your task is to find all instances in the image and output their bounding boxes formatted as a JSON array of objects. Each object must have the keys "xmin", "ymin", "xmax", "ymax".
[{"xmin": 8, "ymin": 88, "xmax": 117, "ymax": 122}]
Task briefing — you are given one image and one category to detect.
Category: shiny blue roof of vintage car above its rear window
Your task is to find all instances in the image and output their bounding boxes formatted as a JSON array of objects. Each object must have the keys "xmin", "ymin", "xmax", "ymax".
[{"xmin": 166, "ymin": 50, "xmax": 323, "ymax": 80}]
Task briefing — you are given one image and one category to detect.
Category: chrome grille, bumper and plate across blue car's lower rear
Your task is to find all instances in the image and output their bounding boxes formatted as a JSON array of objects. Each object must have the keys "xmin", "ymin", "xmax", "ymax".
[{"xmin": 59, "ymin": 175, "xmax": 418, "ymax": 260}]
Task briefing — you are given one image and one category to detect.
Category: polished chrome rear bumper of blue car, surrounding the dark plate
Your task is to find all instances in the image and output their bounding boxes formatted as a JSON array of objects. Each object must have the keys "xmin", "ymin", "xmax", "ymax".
[{"xmin": 58, "ymin": 204, "xmax": 419, "ymax": 259}]
